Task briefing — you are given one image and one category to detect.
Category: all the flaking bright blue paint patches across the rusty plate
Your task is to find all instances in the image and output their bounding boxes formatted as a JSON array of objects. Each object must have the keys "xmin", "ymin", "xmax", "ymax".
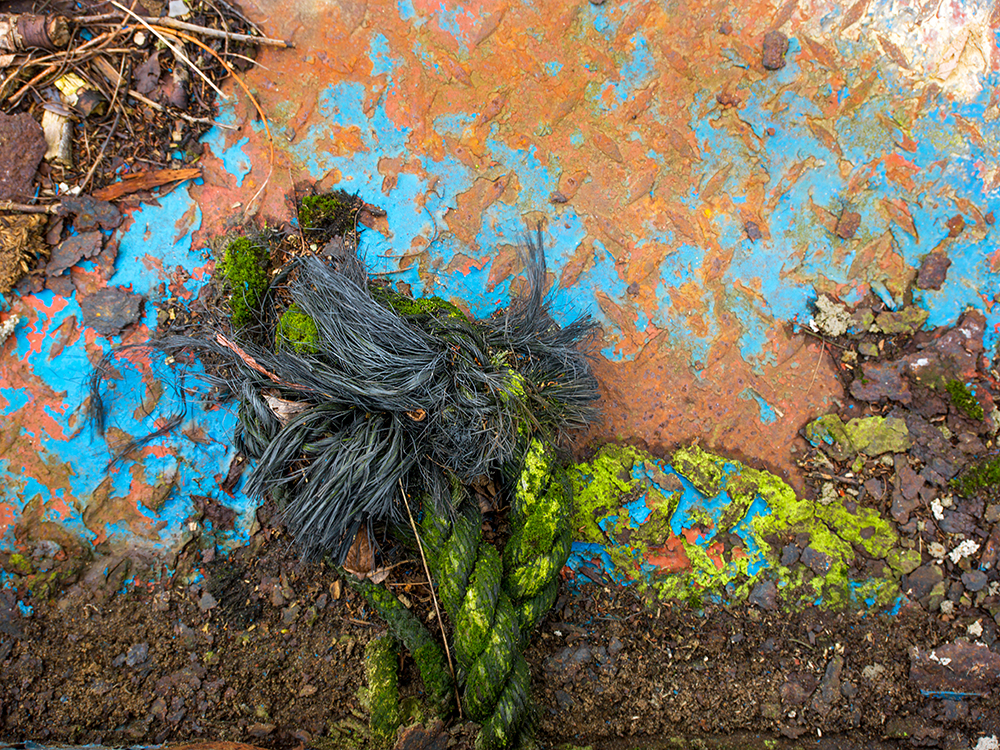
[{"xmin": 0, "ymin": 0, "xmax": 1000, "ymax": 604}]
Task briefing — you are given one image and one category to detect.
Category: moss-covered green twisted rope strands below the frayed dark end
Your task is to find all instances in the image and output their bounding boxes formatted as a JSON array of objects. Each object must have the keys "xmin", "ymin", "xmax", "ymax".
[{"xmin": 360, "ymin": 439, "xmax": 571, "ymax": 750}]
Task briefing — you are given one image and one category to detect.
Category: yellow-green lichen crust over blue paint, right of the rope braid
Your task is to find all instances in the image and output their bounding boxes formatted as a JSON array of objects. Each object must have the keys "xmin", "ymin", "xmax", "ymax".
[{"xmin": 573, "ymin": 447, "xmax": 911, "ymax": 607}]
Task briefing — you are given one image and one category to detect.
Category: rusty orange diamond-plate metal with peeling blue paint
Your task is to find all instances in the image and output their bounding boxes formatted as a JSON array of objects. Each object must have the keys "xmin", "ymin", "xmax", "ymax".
[{"xmin": 0, "ymin": 0, "xmax": 1000, "ymax": 572}]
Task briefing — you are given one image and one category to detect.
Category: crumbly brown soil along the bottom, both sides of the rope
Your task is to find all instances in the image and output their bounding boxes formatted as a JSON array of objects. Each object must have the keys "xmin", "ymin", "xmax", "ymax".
[{"xmin": 0, "ymin": 496, "xmax": 1000, "ymax": 748}]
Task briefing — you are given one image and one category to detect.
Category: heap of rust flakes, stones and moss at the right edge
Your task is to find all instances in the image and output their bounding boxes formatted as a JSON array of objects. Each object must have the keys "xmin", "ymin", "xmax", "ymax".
[{"xmin": 799, "ymin": 299, "xmax": 1000, "ymax": 658}]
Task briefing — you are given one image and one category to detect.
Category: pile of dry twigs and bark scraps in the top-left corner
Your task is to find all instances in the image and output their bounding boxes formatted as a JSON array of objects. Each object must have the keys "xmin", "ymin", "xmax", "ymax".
[{"xmin": 0, "ymin": 1, "xmax": 287, "ymax": 295}]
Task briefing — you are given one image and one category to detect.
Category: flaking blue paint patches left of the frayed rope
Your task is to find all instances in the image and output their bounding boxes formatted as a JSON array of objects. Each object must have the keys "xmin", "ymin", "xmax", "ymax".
[{"xmin": 0, "ymin": 188, "xmax": 253, "ymax": 576}]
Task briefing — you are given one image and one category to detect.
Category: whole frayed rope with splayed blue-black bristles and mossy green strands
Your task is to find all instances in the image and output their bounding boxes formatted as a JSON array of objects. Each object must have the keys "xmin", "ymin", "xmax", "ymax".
[{"xmin": 90, "ymin": 197, "xmax": 597, "ymax": 748}]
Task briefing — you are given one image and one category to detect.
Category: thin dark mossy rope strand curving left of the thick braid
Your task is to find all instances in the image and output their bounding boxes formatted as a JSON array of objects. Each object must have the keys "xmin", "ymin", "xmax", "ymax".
[{"xmin": 347, "ymin": 576, "xmax": 452, "ymax": 716}]
